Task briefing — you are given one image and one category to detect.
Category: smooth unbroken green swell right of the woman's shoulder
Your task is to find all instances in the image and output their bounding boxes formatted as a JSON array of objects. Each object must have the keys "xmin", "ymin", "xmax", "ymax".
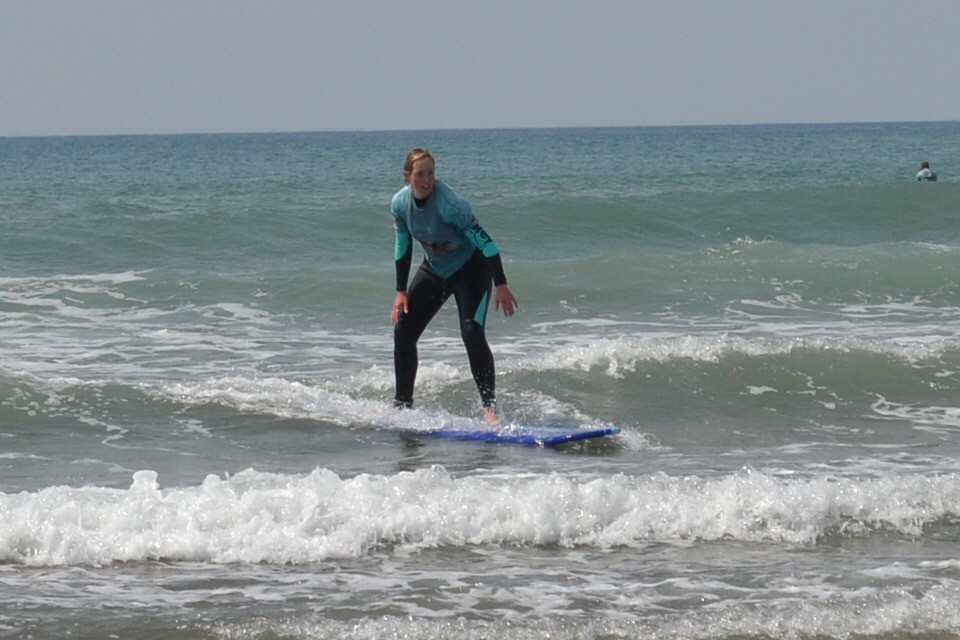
[{"xmin": 498, "ymin": 183, "xmax": 960, "ymax": 255}]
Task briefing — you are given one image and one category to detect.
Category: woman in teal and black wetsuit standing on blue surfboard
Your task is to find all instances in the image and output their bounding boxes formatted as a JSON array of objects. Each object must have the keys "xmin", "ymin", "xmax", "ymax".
[{"xmin": 390, "ymin": 149, "xmax": 517, "ymax": 424}]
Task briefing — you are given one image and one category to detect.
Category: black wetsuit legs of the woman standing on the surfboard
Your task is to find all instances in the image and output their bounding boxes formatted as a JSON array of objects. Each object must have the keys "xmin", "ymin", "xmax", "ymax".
[{"xmin": 393, "ymin": 251, "xmax": 496, "ymax": 407}]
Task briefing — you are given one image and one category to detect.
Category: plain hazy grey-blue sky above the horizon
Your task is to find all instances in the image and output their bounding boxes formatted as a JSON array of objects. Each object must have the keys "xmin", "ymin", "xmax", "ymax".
[{"xmin": 0, "ymin": 0, "xmax": 960, "ymax": 136}]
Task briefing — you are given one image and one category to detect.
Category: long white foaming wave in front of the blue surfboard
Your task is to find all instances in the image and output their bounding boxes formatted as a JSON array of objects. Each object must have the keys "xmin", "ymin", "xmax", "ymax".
[{"xmin": 0, "ymin": 467, "xmax": 960, "ymax": 566}]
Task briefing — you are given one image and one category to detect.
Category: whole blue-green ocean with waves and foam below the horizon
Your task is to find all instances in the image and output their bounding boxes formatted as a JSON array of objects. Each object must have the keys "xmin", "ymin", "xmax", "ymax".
[{"xmin": 0, "ymin": 122, "xmax": 960, "ymax": 640}]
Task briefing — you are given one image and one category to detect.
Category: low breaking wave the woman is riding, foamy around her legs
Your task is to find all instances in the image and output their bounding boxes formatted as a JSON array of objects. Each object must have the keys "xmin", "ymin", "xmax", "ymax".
[{"xmin": 142, "ymin": 321, "xmax": 960, "ymax": 432}]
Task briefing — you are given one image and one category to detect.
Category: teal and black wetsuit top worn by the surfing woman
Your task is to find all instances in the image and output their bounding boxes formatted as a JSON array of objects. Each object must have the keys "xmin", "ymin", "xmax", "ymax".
[{"xmin": 390, "ymin": 180, "xmax": 507, "ymax": 291}]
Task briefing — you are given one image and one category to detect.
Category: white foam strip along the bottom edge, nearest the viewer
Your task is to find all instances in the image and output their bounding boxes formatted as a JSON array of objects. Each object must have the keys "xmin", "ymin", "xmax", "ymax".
[{"xmin": 213, "ymin": 586, "xmax": 960, "ymax": 640}]
